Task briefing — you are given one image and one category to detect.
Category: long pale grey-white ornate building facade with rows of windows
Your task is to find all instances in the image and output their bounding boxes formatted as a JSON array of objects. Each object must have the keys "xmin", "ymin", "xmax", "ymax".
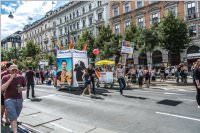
[{"xmin": 21, "ymin": 0, "xmax": 109, "ymax": 51}]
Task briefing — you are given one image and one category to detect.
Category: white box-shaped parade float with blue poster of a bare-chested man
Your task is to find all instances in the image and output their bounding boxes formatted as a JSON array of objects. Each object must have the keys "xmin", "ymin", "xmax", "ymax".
[{"xmin": 56, "ymin": 49, "xmax": 88, "ymax": 90}]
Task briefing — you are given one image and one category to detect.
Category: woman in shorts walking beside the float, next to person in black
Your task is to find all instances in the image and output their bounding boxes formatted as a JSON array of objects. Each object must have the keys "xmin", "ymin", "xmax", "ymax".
[{"xmin": 81, "ymin": 69, "xmax": 91, "ymax": 96}]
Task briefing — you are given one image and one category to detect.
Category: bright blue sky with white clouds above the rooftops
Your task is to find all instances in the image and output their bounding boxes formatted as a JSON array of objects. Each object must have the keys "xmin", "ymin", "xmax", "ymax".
[{"xmin": 0, "ymin": 0, "xmax": 69, "ymax": 40}]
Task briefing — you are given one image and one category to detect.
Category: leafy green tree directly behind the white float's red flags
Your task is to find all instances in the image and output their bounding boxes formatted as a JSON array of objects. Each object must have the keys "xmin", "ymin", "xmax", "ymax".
[{"xmin": 77, "ymin": 30, "xmax": 97, "ymax": 61}]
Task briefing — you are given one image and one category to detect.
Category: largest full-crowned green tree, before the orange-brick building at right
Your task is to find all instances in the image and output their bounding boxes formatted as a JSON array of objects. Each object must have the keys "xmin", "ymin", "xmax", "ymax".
[{"xmin": 159, "ymin": 12, "xmax": 191, "ymax": 65}]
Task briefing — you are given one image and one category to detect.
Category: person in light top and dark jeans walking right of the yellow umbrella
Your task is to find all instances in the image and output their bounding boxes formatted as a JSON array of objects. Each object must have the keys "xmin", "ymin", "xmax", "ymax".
[{"xmin": 116, "ymin": 63, "xmax": 126, "ymax": 95}]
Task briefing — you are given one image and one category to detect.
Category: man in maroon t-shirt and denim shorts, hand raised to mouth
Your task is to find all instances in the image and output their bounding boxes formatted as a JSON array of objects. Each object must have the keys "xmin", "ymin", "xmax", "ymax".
[{"xmin": 1, "ymin": 65, "xmax": 26, "ymax": 133}]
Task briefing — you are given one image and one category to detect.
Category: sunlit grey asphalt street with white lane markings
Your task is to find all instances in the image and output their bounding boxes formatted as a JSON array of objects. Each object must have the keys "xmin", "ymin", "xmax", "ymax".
[{"xmin": 16, "ymin": 84, "xmax": 200, "ymax": 133}]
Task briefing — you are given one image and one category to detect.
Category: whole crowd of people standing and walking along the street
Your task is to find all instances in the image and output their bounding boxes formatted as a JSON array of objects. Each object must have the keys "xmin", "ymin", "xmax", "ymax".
[{"xmin": 1, "ymin": 60, "xmax": 200, "ymax": 133}]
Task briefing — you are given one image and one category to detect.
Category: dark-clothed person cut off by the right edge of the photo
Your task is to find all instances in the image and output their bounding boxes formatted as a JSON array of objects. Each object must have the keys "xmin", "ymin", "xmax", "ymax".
[{"xmin": 194, "ymin": 59, "xmax": 200, "ymax": 109}]
